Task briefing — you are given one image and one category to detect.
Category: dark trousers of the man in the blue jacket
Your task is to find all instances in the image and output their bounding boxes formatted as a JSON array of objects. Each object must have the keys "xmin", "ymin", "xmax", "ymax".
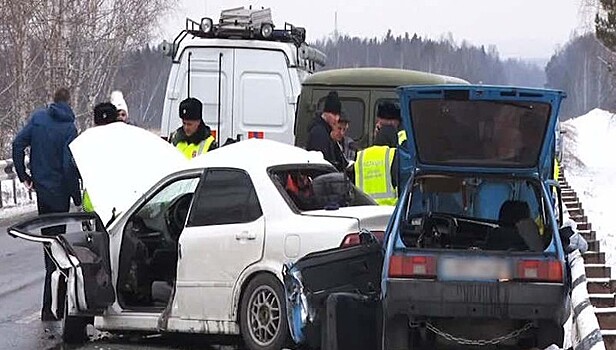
[{"xmin": 37, "ymin": 196, "xmax": 70, "ymax": 317}]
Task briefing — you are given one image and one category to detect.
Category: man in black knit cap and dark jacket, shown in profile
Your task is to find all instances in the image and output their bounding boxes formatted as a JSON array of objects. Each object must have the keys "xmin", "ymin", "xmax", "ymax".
[{"xmin": 306, "ymin": 91, "xmax": 347, "ymax": 171}]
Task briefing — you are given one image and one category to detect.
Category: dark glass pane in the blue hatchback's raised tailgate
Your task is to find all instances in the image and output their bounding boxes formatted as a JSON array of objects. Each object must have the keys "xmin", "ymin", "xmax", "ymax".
[{"xmin": 410, "ymin": 100, "xmax": 550, "ymax": 167}]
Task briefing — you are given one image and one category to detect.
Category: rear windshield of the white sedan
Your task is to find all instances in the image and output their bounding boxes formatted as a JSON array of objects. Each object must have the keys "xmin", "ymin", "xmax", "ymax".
[{"xmin": 269, "ymin": 165, "xmax": 377, "ymax": 211}]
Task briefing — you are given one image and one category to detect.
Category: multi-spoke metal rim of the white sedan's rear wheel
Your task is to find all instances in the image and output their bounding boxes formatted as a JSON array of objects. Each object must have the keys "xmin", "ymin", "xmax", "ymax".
[{"xmin": 246, "ymin": 286, "xmax": 280, "ymax": 346}]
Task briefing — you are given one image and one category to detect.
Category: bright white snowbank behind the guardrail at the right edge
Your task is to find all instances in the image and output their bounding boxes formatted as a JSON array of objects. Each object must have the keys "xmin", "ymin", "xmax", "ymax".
[{"xmin": 562, "ymin": 109, "xmax": 616, "ymax": 277}]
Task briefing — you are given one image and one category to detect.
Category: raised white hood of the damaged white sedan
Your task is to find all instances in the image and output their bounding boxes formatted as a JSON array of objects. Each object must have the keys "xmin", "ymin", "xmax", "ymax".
[{"xmin": 69, "ymin": 123, "xmax": 189, "ymax": 223}]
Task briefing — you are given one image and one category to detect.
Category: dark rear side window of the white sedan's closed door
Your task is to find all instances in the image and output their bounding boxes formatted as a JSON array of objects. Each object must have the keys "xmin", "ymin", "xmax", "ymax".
[{"xmin": 188, "ymin": 169, "xmax": 263, "ymax": 226}]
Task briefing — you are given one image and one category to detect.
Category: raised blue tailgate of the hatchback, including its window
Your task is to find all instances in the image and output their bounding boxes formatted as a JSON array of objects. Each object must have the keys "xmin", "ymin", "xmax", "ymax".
[{"xmin": 398, "ymin": 85, "xmax": 565, "ymax": 175}]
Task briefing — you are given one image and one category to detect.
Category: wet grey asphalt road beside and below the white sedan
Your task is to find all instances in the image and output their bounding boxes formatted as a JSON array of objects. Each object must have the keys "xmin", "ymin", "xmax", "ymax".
[{"xmin": 0, "ymin": 209, "xmax": 241, "ymax": 350}]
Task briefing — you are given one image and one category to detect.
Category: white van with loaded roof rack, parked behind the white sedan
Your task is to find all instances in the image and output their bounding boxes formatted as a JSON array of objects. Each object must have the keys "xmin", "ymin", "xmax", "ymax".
[{"xmin": 160, "ymin": 7, "xmax": 325, "ymax": 144}]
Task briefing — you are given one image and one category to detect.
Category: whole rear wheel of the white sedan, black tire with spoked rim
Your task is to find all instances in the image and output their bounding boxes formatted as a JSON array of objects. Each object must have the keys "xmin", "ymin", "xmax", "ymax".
[{"xmin": 240, "ymin": 274, "xmax": 291, "ymax": 350}]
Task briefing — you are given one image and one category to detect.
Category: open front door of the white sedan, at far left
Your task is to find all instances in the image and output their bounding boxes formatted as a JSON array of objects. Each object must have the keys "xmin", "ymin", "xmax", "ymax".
[{"xmin": 7, "ymin": 213, "xmax": 116, "ymax": 316}]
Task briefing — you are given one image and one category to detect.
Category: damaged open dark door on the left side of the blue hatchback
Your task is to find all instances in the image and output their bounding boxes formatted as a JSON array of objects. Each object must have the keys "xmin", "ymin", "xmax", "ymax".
[{"xmin": 283, "ymin": 233, "xmax": 384, "ymax": 350}]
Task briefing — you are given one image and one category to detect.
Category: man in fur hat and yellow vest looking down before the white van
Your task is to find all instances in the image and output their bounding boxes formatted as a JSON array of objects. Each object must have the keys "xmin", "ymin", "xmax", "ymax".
[{"xmin": 171, "ymin": 97, "xmax": 218, "ymax": 159}]
